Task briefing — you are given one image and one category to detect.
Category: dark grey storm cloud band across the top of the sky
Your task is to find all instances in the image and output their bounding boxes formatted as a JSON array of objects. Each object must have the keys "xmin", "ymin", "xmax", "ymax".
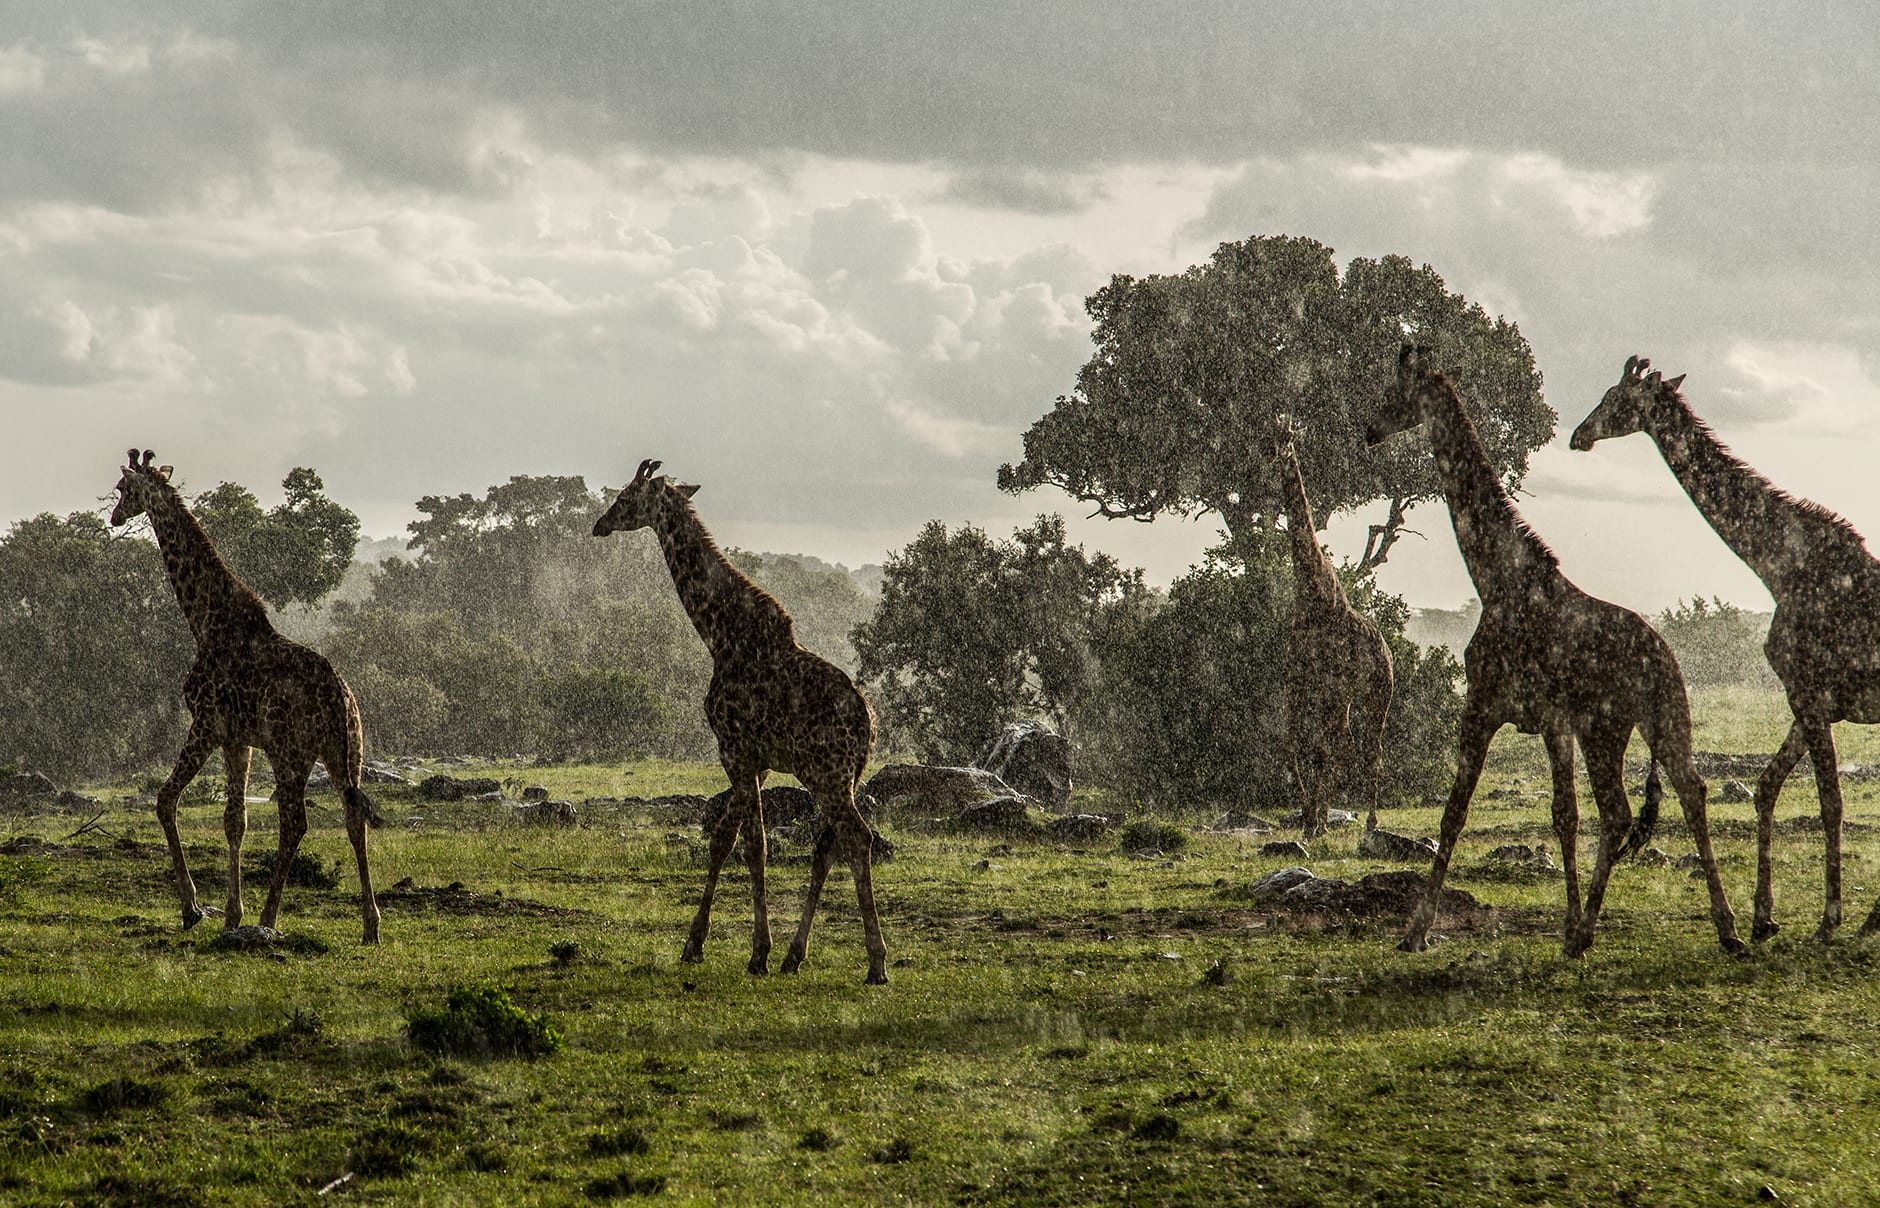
[{"xmin": 0, "ymin": 0, "xmax": 1880, "ymax": 212}]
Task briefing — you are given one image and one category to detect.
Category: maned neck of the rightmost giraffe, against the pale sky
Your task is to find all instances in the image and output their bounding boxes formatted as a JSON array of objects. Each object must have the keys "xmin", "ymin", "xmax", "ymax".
[{"xmin": 1645, "ymin": 393, "xmax": 1831, "ymax": 594}]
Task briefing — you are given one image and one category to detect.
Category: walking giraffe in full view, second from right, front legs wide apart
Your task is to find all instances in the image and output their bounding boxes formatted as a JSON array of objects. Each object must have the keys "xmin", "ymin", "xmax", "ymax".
[{"xmin": 1365, "ymin": 344, "xmax": 1745, "ymax": 956}]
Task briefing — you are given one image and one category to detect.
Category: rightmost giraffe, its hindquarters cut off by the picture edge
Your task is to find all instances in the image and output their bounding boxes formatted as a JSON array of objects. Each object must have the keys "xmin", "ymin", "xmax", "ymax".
[{"xmin": 1572, "ymin": 357, "xmax": 1880, "ymax": 939}]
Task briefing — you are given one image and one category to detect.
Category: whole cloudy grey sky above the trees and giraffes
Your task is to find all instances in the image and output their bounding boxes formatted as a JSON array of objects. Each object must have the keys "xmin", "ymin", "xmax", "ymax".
[{"xmin": 0, "ymin": 0, "xmax": 1880, "ymax": 611}]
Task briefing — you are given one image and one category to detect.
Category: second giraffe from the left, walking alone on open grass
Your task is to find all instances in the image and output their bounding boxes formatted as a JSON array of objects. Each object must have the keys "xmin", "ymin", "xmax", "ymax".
[{"xmin": 594, "ymin": 458, "xmax": 887, "ymax": 984}]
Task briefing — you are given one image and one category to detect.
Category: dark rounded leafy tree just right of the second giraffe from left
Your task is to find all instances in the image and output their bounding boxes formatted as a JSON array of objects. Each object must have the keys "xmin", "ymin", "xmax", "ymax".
[{"xmin": 852, "ymin": 517, "xmax": 1143, "ymax": 763}]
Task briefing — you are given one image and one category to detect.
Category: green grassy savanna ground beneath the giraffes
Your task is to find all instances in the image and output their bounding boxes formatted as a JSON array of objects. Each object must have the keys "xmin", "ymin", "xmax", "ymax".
[{"xmin": 0, "ymin": 691, "xmax": 1880, "ymax": 1206}]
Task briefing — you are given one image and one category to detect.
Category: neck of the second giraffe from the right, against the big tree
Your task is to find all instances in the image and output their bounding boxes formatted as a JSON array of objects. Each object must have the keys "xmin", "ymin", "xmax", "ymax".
[{"xmin": 1423, "ymin": 378, "xmax": 1560, "ymax": 605}]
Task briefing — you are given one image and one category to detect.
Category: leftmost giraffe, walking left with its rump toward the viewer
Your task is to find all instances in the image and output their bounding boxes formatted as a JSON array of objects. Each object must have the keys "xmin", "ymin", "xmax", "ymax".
[{"xmin": 111, "ymin": 449, "xmax": 380, "ymax": 943}]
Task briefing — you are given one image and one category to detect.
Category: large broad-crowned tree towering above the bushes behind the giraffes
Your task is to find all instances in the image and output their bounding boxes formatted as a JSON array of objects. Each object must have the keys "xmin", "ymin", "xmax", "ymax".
[{"xmin": 998, "ymin": 235, "xmax": 1555, "ymax": 571}]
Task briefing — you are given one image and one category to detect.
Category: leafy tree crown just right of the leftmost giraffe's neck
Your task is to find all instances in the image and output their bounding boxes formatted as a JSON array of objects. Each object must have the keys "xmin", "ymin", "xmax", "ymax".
[{"xmin": 194, "ymin": 466, "xmax": 359, "ymax": 609}]
